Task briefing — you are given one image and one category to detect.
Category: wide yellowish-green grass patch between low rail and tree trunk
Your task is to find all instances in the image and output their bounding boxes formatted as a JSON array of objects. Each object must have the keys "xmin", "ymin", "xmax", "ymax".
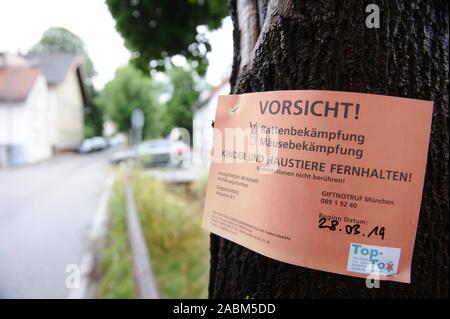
[{"xmin": 133, "ymin": 173, "xmax": 209, "ymax": 298}]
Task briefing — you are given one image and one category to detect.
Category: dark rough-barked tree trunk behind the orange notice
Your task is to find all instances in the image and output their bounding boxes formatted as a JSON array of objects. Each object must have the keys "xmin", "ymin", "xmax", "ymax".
[{"xmin": 209, "ymin": 0, "xmax": 449, "ymax": 299}]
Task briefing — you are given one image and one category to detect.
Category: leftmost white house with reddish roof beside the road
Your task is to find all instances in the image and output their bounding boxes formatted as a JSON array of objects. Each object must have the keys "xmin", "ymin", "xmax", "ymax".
[{"xmin": 0, "ymin": 56, "xmax": 52, "ymax": 166}]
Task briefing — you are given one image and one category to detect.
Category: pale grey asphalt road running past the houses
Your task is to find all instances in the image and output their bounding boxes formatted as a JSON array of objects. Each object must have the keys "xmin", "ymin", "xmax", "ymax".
[{"xmin": 0, "ymin": 151, "xmax": 110, "ymax": 298}]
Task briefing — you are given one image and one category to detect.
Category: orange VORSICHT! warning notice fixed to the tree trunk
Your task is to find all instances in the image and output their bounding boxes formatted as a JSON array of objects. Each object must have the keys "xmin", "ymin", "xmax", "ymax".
[{"xmin": 203, "ymin": 90, "xmax": 432, "ymax": 283}]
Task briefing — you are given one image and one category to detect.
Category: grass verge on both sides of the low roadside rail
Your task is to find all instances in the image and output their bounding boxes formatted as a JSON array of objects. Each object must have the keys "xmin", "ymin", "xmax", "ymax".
[{"xmin": 99, "ymin": 171, "xmax": 209, "ymax": 298}]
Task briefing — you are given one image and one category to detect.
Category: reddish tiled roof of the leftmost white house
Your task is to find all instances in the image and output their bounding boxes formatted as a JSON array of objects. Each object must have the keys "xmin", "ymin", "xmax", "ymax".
[{"xmin": 0, "ymin": 67, "xmax": 40, "ymax": 102}]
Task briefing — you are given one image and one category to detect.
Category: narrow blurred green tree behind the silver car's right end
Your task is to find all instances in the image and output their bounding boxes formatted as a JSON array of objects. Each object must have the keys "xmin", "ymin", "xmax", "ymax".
[{"xmin": 163, "ymin": 67, "xmax": 199, "ymax": 137}]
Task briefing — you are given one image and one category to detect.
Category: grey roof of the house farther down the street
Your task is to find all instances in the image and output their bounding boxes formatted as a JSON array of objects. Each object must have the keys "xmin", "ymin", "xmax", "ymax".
[{"xmin": 26, "ymin": 53, "xmax": 80, "ymax": 85}]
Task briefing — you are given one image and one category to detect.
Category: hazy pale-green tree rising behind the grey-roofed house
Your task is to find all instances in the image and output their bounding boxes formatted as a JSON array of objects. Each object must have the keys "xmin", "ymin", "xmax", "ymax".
[{"xmin": 29, "ymin": 27, "xmax": 103, "ymax": 137}]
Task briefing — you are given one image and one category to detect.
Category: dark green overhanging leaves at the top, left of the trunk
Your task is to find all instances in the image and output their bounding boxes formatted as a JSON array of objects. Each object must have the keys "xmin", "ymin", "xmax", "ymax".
[{"xmin": 106, "ymin": 0, "xmax": 227, "ymax": 74}]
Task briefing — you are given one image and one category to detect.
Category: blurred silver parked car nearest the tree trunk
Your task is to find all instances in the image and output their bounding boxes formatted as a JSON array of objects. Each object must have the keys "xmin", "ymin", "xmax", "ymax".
[{"xmin": 111, "ymin": 139, "xmax": 190, "ymax": 166}]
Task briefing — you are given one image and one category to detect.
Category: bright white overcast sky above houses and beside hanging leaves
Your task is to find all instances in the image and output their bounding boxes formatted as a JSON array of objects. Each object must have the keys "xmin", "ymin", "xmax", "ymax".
[{"xmin": 0, "ymin": 0, "xmax": 233, "ymax": 89}]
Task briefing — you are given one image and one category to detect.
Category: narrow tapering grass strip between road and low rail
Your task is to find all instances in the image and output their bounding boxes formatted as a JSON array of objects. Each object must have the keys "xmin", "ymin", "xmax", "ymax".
[{"xmin": 96, "ymin": 178, "xmax": 136, "ymax": 298}]
